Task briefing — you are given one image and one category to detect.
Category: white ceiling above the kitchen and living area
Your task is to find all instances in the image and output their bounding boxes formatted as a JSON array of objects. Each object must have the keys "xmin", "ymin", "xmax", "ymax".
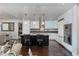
[{"xmin": 0, "ymin": 3, "xmax": 74, "ymax": 20}]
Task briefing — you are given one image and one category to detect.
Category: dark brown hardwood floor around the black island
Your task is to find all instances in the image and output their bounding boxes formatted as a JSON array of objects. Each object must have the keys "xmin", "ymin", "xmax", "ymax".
[{"xmin": 21, "ymin": 41, "xmax": 71, "ymax": 56}]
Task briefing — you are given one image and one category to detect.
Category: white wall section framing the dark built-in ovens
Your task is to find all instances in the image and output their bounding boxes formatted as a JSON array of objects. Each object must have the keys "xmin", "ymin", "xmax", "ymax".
[{"xmin": 57, "ymin": 8, "xmax": 73, "ymax": 52}]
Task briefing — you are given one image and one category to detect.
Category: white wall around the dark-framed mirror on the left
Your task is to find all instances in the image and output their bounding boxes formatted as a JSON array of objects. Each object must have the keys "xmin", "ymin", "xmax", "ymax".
[{"xmin": 0, "ymin": 19, "xmax": 22, "ymax": 39}]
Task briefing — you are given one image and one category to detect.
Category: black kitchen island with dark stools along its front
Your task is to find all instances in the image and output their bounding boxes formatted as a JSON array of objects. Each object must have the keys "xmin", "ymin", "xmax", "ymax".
[{"xmin": 21, "ymin": 35, "xmax": 49, "ymax": 46}]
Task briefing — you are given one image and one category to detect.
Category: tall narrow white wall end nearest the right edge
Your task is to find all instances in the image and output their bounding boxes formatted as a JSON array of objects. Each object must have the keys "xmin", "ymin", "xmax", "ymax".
[{"xmin": 72, "ymin": 5, "xmax": 79, "ymax": 55}]
